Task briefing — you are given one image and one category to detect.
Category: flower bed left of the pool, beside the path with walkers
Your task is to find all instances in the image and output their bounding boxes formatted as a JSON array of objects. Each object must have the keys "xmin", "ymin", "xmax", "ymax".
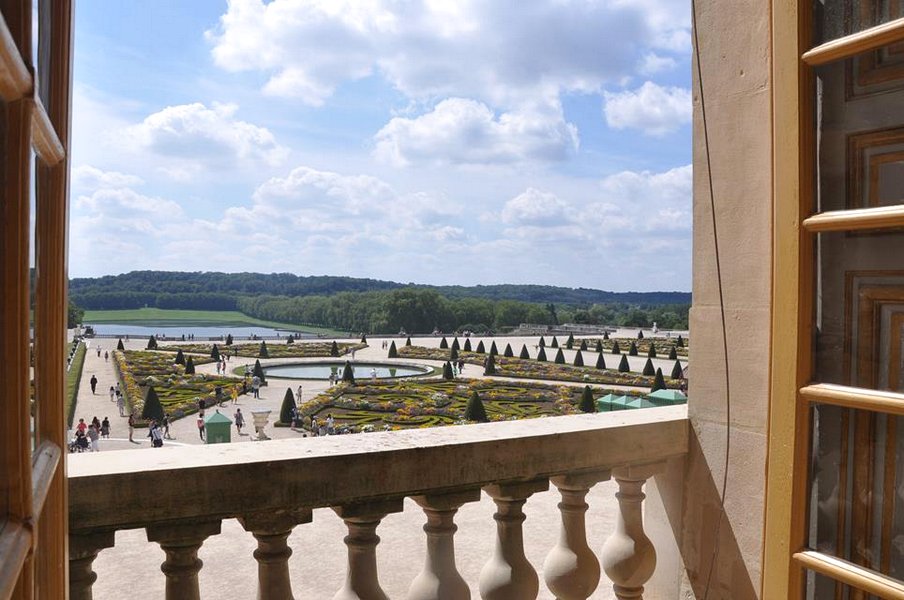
[{"xmin": 113, "ymin": 350, "xmax": 242, "ymax": 419}]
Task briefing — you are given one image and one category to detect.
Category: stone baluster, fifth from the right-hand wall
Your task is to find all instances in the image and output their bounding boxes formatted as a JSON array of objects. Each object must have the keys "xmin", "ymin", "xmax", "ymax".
[{"xmin": 333, "ymin": 498, "xmax": 402, "ymax": 600}]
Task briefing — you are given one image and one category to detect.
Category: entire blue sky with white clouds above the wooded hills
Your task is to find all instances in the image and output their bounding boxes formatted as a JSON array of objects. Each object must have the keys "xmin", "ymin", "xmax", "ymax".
[{"xmin": 70, "ymin": 0, "xmax": 691, "ymax": 291}]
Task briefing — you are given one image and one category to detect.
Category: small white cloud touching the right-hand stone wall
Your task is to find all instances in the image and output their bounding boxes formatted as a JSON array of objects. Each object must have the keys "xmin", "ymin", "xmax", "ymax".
[{"xmin": 603, "ymin": 81, "xmax": 692, "ymax": 136}]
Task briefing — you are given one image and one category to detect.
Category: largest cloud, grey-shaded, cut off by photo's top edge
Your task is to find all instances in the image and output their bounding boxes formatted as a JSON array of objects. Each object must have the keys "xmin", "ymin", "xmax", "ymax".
[{"xmin": 207, "ymin": 0, "xmax": 690, "ymax": 106}]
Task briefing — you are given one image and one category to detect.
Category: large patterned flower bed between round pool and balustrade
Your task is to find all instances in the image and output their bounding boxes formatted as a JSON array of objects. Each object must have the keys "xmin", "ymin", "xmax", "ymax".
[{"xmin": 301, "ymin": 379, "xmax": 636, "ymax": 432}]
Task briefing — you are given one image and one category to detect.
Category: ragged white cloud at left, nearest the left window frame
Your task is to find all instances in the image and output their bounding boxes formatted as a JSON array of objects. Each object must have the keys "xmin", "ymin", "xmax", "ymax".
[{"xmin": 123, "ymin": 102, "xmax": 288, "ymax": 170}]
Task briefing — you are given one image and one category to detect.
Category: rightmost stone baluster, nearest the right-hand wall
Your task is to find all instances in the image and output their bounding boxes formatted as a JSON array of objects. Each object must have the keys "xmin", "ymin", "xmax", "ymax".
[{"xmin": 602, "ymin": 463, "xmax": 662, "ymax": 600}]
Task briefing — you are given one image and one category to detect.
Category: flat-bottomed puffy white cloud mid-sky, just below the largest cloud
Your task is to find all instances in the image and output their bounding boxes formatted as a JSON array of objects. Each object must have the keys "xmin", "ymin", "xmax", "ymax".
[{"xmin": 374, "ymin": 98, "xmax": 578, "ymax": 166}]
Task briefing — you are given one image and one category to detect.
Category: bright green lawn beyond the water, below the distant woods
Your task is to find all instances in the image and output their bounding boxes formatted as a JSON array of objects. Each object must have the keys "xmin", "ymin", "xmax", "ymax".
[{"xmin": 83, "ymin": 308, "xmax": 342, "ymax": 337}]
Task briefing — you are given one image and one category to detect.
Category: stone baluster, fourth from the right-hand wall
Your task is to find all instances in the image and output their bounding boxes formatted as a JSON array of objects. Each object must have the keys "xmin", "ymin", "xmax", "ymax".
[{"xmin": 407, "ymin": 489, "xmax": 480, "ymax": 600}]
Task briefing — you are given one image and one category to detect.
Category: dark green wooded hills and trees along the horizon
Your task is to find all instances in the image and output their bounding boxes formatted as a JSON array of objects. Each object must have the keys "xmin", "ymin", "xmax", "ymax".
[{"xmin": 69, "ymin": 271, "xmax": 691, "ymax": 333}]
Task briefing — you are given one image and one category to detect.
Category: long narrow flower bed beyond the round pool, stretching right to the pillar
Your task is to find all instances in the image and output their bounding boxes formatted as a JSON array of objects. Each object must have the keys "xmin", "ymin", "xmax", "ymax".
[{"xmin": 398, "ymin": 346, "xmax": 681, "ymax": 391}]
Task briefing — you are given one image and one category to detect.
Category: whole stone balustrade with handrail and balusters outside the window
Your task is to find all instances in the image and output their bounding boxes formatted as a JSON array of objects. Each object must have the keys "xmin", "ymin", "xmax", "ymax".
[{"xmin": 69, "ymin": 406, "xmax": 688, "ymax": 600}]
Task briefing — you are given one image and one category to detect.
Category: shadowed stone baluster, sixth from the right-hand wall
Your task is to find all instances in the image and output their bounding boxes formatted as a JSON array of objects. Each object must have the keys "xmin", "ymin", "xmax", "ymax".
[{"xmin": 238, "ymin": 509, "xmax": 311, "ymax": 600}]
